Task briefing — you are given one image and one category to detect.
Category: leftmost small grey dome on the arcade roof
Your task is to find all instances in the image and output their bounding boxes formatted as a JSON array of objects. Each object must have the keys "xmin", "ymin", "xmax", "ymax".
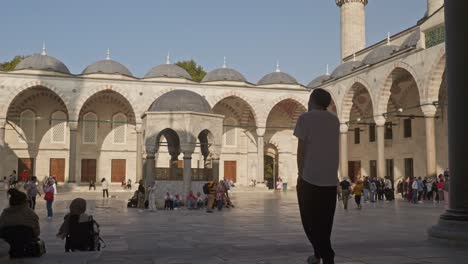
[{"xmin": 15, "ymin": 54, "xmax": 70, "ymax": 74}]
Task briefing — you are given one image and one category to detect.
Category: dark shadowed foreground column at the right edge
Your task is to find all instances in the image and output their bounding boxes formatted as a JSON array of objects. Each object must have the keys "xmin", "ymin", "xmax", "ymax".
[{"xmin": 429, "ymin": 0, "xmax": 468, "ymax": 242}]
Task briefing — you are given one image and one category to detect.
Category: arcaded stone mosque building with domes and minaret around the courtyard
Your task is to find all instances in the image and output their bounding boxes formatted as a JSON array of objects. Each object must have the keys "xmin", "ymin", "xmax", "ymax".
[{"xmin": 0, "ymin": 0, "xmax": 448, "ymax": 192}]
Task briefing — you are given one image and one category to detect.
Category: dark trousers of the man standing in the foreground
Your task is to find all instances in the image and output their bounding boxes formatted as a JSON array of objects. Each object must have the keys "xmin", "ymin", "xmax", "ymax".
[{"xmin": 297, "ymin": 177, "xmax": 337, "ymax": 264}]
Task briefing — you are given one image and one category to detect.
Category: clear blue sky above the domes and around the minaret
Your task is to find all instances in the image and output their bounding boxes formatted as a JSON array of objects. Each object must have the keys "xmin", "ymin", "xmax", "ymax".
[{"xmin": 0, "ymin": 0, "xmax": 426, "ymax": 84}]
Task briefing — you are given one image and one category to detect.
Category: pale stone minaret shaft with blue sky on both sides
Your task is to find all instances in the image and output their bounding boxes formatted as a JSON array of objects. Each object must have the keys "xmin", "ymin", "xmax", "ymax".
[{"xmin": 335, "ymin": 0, "xmax": 368, "ymax": 59}]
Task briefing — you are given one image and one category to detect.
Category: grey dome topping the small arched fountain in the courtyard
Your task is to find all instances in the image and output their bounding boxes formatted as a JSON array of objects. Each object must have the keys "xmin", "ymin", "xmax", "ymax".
[{"xmin": 149, "ymin": 90, "xmax": 212, "ymax": 114}]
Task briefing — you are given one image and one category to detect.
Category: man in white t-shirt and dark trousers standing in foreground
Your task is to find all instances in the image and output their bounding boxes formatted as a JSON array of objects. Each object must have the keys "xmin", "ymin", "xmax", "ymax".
[{"xmin": 294, "ymin": 89, "xmax": 340, "ymax": 264}]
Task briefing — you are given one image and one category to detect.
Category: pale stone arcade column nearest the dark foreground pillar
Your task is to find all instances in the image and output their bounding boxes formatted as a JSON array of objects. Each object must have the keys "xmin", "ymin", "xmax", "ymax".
[{"xmin": 422, "ymin": 105, "xmax": 437, "ymax": 177}]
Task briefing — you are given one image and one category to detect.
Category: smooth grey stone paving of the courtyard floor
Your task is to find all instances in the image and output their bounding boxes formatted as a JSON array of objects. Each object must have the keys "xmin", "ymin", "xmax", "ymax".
[{"xmin": 0, "ymin": 191, "xmax": 468, "ymax": 264}]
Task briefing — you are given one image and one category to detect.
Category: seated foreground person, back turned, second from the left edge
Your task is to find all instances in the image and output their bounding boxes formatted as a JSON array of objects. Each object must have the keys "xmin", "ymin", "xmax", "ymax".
[{"xmin": 57, "ymin": 198, "xmax": 100, "ymax": 252}]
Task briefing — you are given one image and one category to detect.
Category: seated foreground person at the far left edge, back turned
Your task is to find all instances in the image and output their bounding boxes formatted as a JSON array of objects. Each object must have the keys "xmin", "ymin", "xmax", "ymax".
[{"xmin": 0, "ymin": 189, "xmax": 45, "ymax": 258}]
